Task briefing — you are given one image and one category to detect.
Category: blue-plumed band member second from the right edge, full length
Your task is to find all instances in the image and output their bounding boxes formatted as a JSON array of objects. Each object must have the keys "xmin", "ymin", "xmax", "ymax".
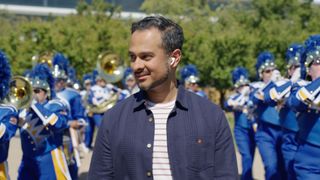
[{"xmin": 265, "ymin": 44, "xmax": 304, "ymax": 179}]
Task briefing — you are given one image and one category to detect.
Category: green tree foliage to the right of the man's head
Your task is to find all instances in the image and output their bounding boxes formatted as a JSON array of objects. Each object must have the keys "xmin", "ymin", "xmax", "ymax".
[{"xmin": 141, "ymin": 0, "xmax": 319, "ymax": 103}]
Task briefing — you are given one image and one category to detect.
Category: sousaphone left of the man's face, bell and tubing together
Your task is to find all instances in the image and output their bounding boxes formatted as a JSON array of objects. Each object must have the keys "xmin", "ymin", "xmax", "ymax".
[{"xmin": 85, "ymin": 53, "xmax": 125, "ymax": 116}]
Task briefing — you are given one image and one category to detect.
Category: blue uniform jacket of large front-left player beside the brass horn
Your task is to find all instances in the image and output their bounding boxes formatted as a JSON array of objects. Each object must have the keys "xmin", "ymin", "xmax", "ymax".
[{"xmin": 20, "ymin": 99, "xmax": 67, "ymax": 158}]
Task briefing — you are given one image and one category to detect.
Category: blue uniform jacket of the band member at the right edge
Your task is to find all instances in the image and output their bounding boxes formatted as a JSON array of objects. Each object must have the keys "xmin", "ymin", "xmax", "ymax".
[{"xmin": 289, "ymin": 78, "xmax": 320, "ymax": 146}]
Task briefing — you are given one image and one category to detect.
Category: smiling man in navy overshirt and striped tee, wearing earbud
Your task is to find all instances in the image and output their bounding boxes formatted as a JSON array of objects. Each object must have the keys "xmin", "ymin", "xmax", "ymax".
[{"xmin": 89, "ymin": 16, "xmax": 238, "ymax": 180}]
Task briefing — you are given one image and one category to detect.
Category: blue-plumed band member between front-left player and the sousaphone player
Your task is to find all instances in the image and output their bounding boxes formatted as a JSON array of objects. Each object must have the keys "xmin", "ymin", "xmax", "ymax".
[{"xmin": 52, "ymin": 53, "xmax": 86, "ymax": 180}]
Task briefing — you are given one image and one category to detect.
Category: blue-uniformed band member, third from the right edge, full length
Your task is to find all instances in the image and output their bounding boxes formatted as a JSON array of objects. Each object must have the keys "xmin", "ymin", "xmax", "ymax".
[{"xmin": 250, "ymin": 52, "xmax": 285, "ymax": 180}]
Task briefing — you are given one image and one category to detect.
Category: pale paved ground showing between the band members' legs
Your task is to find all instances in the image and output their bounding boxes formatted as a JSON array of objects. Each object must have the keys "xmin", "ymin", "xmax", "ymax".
[{"xmin": 8, "ymin": 136, "xmax": 264, "ymax": 180}]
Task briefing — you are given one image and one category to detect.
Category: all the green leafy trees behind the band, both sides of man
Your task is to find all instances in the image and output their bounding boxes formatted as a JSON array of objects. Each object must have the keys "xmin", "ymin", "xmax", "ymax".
[{"xmin": 0, "ymin": 0, "xmax": 320, "ymax": 105}]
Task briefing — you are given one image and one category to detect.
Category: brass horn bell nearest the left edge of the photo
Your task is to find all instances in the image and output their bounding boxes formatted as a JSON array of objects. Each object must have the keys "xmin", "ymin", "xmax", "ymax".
[{"xmin": 4, "ymin": 76, "xmax": 33, "ymax": 109}]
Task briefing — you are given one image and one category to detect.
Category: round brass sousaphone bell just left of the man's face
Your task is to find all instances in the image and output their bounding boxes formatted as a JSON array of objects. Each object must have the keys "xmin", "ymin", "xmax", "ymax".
[{"xmin": 97, "ymin": 52, "xmax": 124, "ymax": 83}]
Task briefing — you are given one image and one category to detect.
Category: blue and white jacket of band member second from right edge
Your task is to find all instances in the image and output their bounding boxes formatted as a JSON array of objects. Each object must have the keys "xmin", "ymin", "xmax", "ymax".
[{"xmin": 264, "ymin": 80, "xmax": 299, "ymax": 132}]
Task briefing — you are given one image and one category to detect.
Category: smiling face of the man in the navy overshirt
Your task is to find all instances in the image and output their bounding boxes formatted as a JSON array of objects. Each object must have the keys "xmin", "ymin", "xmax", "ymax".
[{"xmin": 129, "ymin": 28, "xmax": 171, "ymax": 91}]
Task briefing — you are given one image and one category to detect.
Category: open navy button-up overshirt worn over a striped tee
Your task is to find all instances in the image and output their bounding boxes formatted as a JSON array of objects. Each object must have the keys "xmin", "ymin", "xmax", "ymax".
[{"xmin": 88, "ymin": 86, "xmax": 238, "ymax": 180}]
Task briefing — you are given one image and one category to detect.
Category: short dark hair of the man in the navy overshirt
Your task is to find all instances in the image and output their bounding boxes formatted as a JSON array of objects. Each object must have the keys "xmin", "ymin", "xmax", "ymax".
[{"xmin": 131, "ymin": 16, "xmax": 184, "ymax": 54}]
